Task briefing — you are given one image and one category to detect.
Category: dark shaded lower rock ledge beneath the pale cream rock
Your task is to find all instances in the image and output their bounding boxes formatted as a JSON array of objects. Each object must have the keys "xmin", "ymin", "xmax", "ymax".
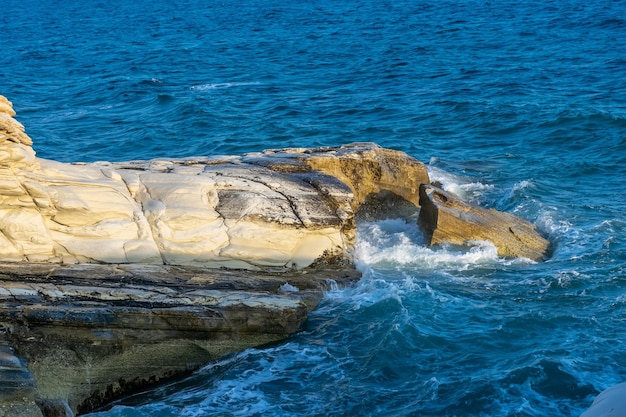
[{"xmin": 0, "ymin": 263, "xmax": 359, "ymax": 416}]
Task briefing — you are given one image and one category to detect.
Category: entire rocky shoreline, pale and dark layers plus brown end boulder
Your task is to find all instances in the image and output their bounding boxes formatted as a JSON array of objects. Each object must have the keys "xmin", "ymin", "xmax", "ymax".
[{"xmin": 0, "ymin": 96, "xmax": 550, "ymax": 417}]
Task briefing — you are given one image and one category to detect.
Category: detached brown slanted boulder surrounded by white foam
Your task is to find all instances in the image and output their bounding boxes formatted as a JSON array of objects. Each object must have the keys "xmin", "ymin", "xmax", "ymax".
[{"xmin": 418, "ymin": 184, "xmax": 550, "ymax": 261}]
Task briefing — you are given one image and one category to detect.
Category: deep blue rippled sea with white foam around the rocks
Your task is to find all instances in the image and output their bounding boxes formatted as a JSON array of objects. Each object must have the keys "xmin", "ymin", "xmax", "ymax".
[{"xmin": 0, "ymin": 0, "xmax": 626, "ymax": 417}]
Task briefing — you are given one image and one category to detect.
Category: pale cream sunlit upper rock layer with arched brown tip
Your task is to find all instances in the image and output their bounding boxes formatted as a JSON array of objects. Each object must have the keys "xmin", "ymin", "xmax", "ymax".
[{"xmin": 0, "ymin": 96, "xmax": 429, "ymax": 269}]
